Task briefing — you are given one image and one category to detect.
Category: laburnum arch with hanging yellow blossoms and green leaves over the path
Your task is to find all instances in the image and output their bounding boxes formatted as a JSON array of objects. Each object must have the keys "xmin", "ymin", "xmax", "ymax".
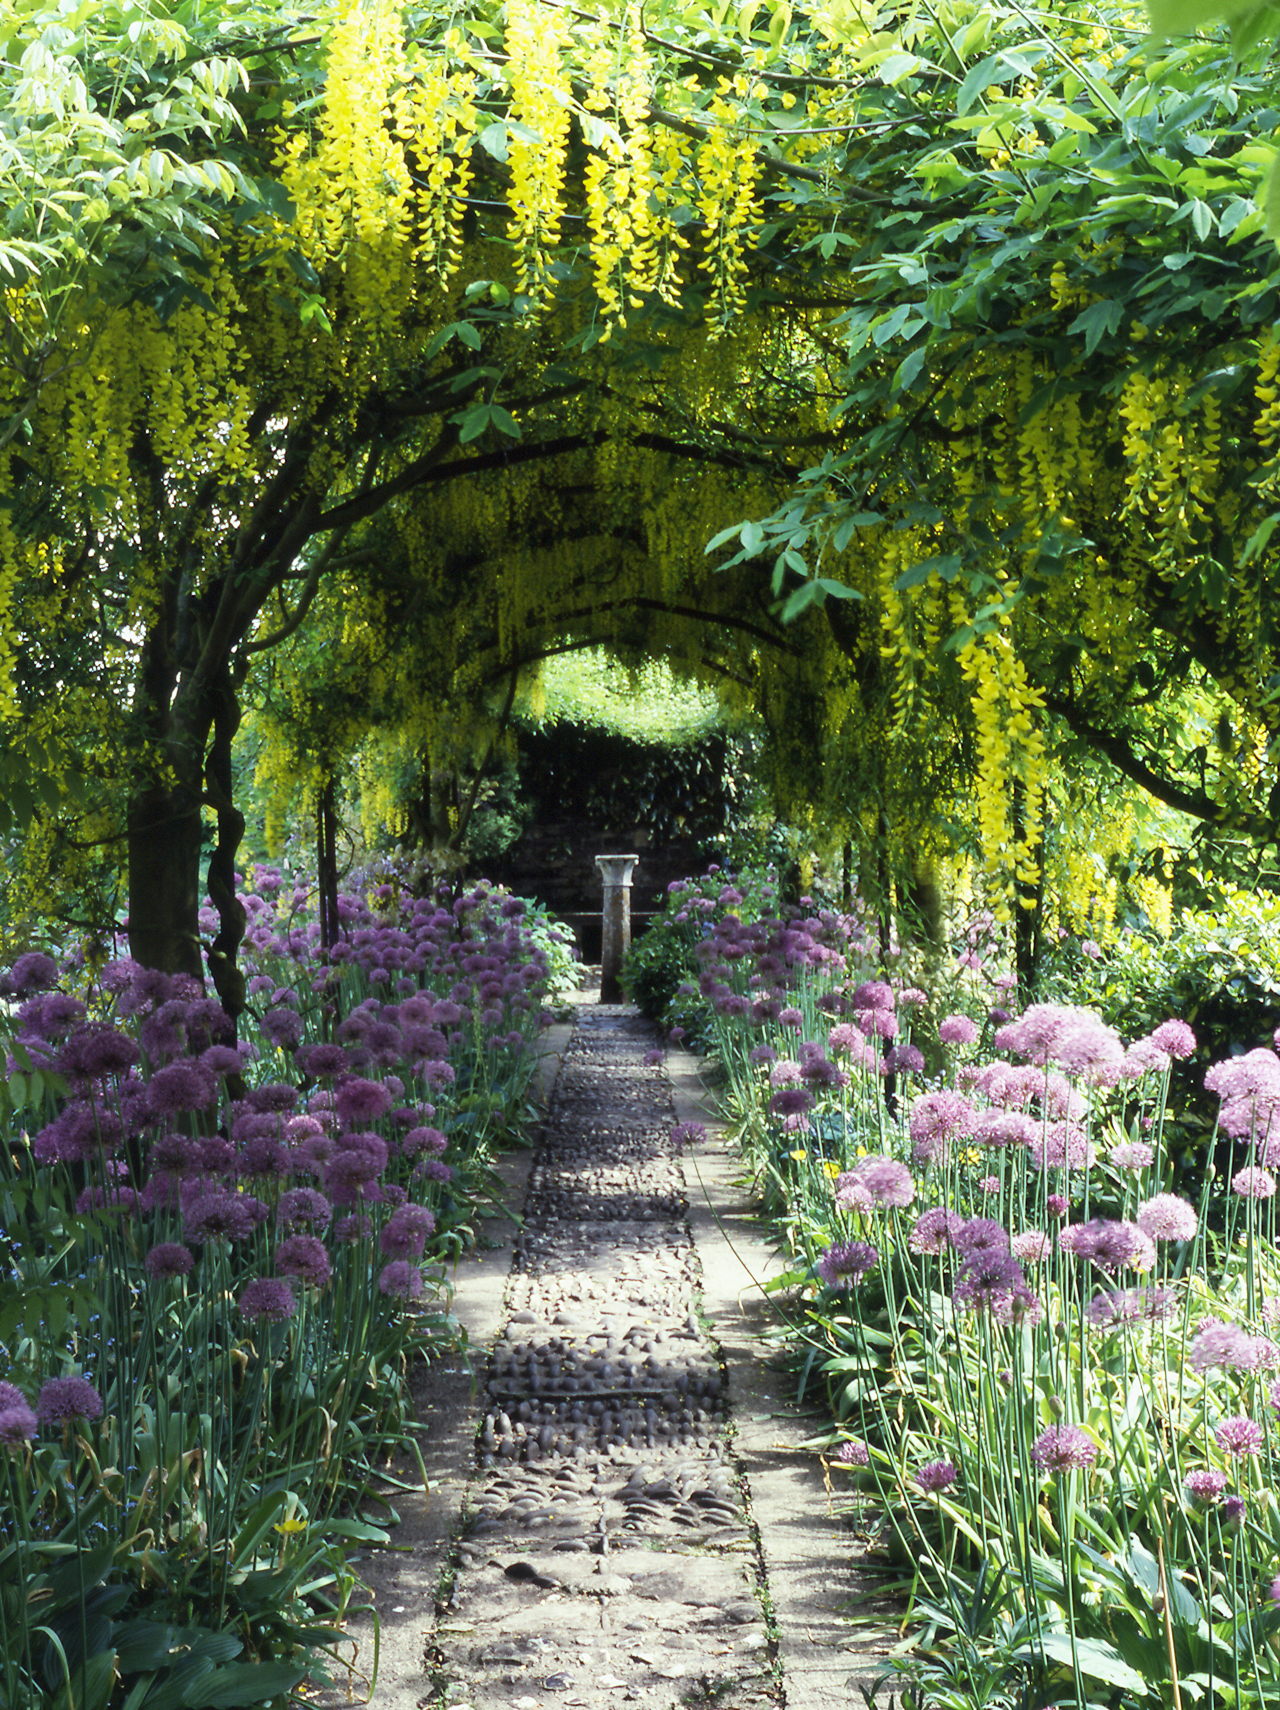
[{"xmin": 0, "ymin": 0, "xmax": 1277, "ymax": 1009}]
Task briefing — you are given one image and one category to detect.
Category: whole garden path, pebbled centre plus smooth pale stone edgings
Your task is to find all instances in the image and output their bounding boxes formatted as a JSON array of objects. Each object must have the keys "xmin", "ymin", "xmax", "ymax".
[{"xmin": 324, "ymin": 992, "xmax": 895, "ymax": 1710}]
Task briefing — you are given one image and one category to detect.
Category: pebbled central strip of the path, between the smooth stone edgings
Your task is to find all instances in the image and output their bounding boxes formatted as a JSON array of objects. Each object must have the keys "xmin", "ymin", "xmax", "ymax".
[{"xmin": 434, "ymin": 1007, "xmax": 781, "ymax": 1710}]
